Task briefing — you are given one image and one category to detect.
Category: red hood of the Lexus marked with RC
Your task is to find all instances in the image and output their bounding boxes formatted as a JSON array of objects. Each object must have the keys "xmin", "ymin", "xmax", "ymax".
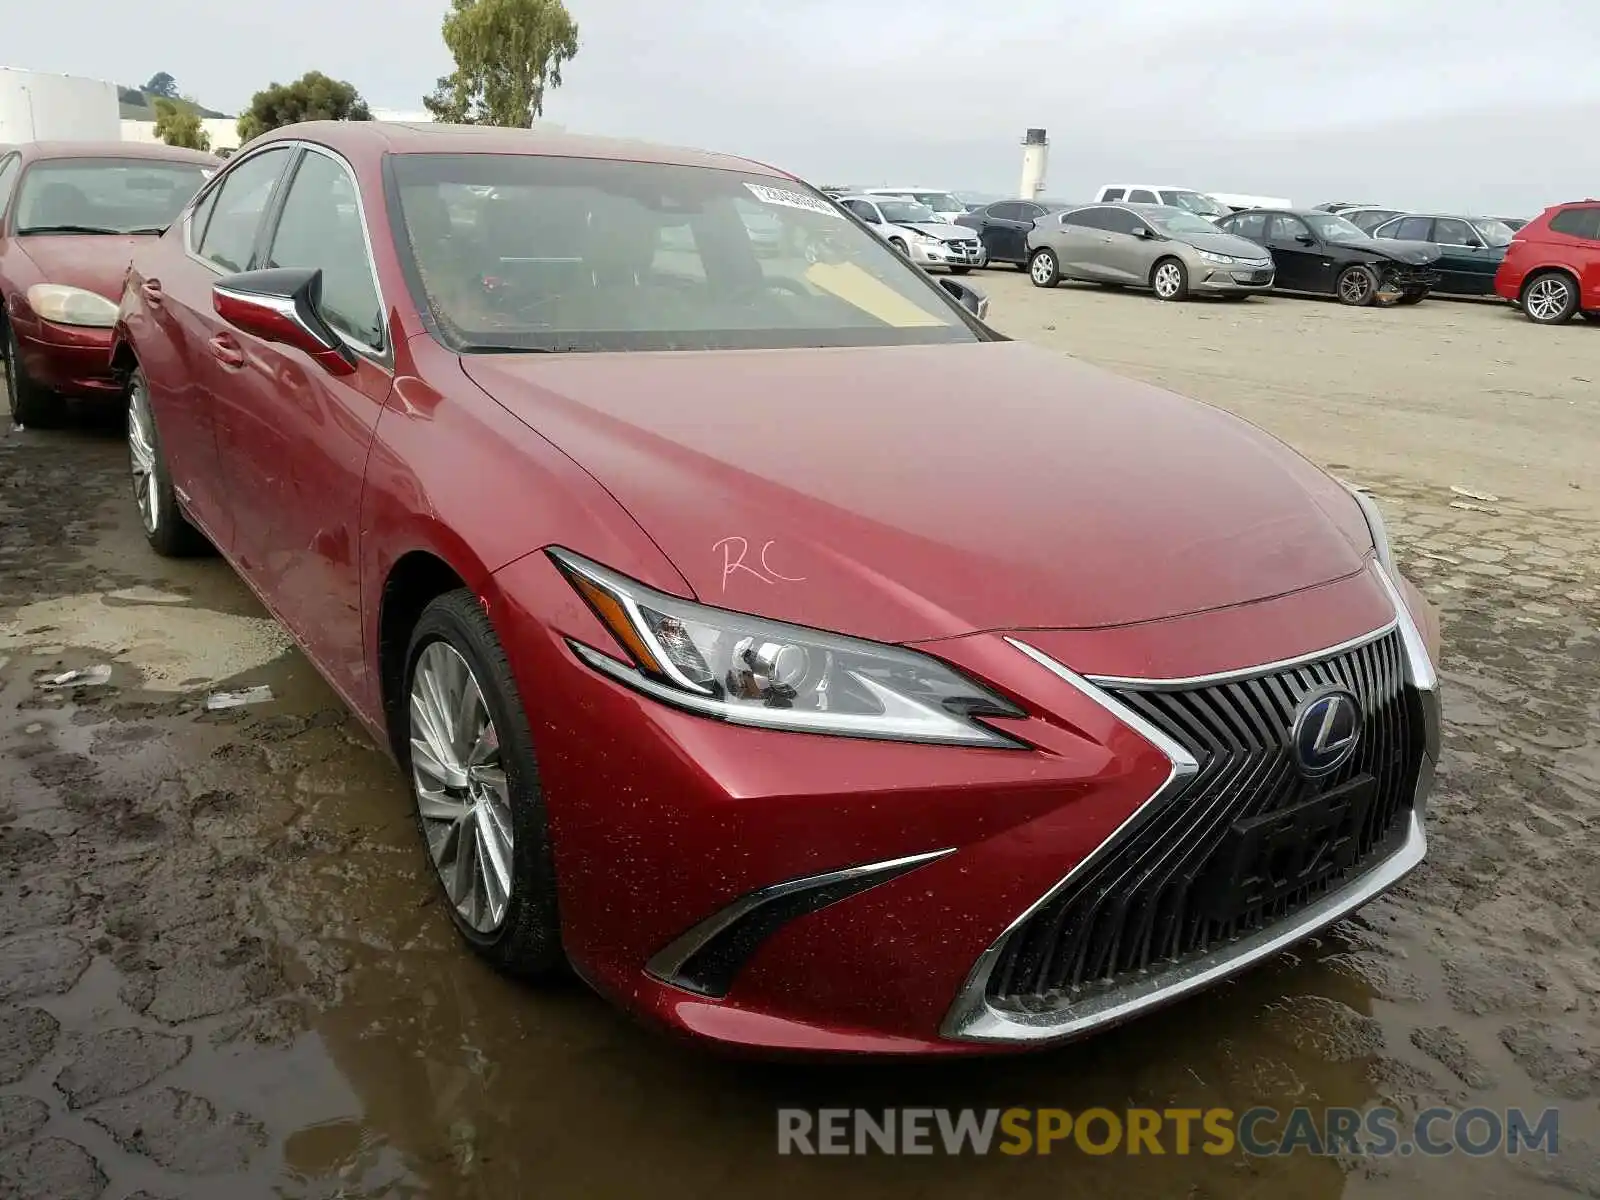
[{"xmin": 462, "ymin": 342, "xmax": 1370, "ymax": 642}]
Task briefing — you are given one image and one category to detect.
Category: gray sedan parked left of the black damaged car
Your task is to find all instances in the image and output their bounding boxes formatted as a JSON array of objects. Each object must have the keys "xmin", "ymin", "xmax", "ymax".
[{"xmin": 1027, "ymin": 205, "xmax": 1274, "ymax": 301}]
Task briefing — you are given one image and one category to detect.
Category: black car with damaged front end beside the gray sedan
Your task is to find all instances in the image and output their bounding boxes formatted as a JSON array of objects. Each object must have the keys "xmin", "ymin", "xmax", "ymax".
[{"xmin": 1216, "ymin": 208, "xmax": 1440, "ymax": 306}]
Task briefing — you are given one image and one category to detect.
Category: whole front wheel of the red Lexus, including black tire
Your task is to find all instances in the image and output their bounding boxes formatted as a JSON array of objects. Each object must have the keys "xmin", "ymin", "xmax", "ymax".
[{"xmin": 402, "ymin": 587, "xmax": 565, "ymax": 979}]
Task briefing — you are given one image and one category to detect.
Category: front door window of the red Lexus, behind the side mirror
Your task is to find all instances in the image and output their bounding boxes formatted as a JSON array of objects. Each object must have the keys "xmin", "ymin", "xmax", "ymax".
[{"xmin": 267, "ymin": 150, "xmax": 384, "ymax": 347}]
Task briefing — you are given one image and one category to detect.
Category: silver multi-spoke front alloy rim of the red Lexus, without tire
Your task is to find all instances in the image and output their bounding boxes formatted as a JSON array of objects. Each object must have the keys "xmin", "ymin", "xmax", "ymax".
[{"xmin": 411, "ymin": 642, "xmax": 514, "ymax": 933}]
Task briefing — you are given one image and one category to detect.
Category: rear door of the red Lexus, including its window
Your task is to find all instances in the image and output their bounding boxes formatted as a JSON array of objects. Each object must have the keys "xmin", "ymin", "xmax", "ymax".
[{"xmin": 125, "ymin": 146, "xmax": 293, "ymax": 550}]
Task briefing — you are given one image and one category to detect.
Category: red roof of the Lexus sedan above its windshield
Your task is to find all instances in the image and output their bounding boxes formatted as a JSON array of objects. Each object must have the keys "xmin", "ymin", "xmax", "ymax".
[{"xmin": 248, "ymin": 122, "xmax": 784, "ymax": 182}]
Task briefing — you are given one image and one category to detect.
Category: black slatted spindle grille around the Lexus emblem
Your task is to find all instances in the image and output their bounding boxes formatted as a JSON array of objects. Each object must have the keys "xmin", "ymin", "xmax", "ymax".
[{"xmin": 989, "ymin": 630, "xmax": 1422, "ymax": 1010}]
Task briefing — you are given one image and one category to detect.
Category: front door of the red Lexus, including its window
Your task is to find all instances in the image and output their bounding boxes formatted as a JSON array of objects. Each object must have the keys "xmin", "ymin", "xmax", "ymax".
[{"xmin": 218, "ymin": 144, "xmax": 394, "ymax": 696}]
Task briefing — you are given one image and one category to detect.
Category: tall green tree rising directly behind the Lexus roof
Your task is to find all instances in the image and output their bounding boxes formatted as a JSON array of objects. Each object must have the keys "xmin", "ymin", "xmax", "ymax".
[{"xmin": 422, "ymin": 0, "xmax": 578, "ymax": 128}]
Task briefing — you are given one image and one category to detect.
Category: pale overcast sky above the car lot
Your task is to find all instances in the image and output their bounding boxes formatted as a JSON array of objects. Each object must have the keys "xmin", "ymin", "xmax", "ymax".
[{"xmin": 9, "ymin": 0, "xmax": 1600, "ymax": 213}]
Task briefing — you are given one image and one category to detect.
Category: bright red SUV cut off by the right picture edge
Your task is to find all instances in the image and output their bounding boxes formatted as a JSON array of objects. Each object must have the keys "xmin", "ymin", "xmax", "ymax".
[{"xmin": 1494, "ymin": 200, "xmax": 1600, "ymax": 325}]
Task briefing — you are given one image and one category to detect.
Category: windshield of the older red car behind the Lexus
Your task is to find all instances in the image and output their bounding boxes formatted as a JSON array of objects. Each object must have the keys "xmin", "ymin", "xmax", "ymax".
[{"xmin": 16, "ymin": 158, "xmax": 210, "ymax": 235}]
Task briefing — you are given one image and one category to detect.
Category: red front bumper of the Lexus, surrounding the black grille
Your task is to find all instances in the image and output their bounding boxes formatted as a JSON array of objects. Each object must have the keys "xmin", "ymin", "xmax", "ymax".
[{"xmin": 490, "ymin": 554, "xmax": 1437, "ymax": 1054}]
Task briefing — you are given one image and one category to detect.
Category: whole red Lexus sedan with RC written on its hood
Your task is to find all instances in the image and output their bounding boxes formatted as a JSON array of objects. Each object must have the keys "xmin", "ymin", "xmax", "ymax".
[{"xmin": 115, "ymin": 123, "xmax": 1438, "ymax": 1054}]
